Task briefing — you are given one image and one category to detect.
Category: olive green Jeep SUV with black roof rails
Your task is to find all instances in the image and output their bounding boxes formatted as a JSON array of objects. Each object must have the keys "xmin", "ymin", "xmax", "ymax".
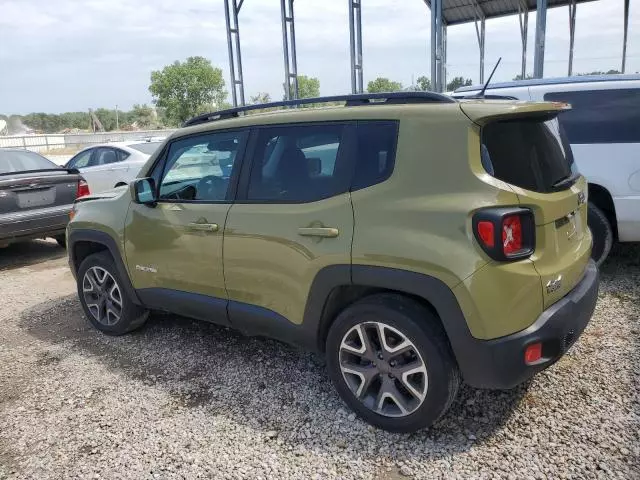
[{"xmin": 67, "ymin": 92, "xmax": 598, "ymax": 432}]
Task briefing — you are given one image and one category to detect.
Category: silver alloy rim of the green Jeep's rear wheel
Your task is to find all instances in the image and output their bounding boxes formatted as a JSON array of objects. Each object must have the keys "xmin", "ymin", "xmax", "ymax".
[{"xmin": 339, "ymin": 322, "xmax": 429, "ymax": 417}]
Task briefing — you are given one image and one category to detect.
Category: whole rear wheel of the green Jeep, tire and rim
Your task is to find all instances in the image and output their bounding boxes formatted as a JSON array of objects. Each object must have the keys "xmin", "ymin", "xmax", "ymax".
[{"xmin": 326, "ymin": 294, "xmax": 460, "ymax": 433}]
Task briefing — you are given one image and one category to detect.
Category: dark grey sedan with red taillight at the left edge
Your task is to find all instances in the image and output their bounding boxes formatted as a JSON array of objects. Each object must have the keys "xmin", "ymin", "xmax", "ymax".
[{"xmin": 0, "ymin": 148, "xmax": 89, "ymax": 247}]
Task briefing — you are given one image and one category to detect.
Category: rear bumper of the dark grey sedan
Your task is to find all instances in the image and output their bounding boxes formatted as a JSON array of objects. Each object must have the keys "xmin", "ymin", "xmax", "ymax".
[{"xmin": 0, "ymin": 205, "xmax": 71, "ymax": 244}]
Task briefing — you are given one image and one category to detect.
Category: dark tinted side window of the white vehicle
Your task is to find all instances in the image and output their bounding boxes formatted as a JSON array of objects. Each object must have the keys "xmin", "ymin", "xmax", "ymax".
[{"xmin": 544, "ymin": 88, "xmax": 640, "ymax": 143}]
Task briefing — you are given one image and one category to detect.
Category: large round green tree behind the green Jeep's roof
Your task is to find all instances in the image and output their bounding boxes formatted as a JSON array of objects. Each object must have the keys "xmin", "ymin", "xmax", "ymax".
[{"xmin": 149, "ymin": 57, "xmax": 227, "ymax": 123}]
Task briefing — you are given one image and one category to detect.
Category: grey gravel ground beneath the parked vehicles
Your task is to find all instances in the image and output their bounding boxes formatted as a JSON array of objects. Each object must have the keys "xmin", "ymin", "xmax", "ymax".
[{"xmin": 0, "ymin": 241, "xmax": 640, "ymax": 479}]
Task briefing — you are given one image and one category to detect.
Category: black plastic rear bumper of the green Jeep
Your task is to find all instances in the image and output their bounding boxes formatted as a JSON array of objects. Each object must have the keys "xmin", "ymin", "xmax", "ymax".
[{"xmin": 456, "ymin": 261, "xmax": 599, "ymax": 389}]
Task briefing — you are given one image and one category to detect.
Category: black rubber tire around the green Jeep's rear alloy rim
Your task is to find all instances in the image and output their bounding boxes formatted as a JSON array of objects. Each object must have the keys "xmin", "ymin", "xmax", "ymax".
[{"xmin": 326, "ymin": 294, "xmax": 460, "ymax": 433}]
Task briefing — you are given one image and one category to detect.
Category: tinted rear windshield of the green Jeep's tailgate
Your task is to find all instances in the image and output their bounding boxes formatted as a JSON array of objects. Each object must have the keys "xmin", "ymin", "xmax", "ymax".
[{"xmin": 481, "ymin": 117, "xmax": 577, "ymax": 193}]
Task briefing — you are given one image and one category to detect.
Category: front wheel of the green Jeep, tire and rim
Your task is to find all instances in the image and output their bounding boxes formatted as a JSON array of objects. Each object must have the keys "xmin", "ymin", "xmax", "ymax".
[{"xmin": 77, "ymin": 252, "xmax": 149, "ymax": 335}]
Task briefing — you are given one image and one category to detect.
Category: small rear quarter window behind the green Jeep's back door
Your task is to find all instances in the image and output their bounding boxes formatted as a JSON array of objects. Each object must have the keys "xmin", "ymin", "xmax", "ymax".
[{"xmin": 352, "ymin": 121, "xmax": 398, "ymax": 190}]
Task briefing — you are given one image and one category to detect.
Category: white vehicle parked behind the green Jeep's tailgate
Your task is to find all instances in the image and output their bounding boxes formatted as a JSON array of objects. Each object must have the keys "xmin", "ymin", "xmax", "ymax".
[{"xmin": 453, "ymin": 75, "xmax": 640, "ymax": 264}]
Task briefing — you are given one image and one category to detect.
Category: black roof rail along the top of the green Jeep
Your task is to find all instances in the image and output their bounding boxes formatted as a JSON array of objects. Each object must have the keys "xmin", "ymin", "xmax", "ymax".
[{"xmin": 182, "ymin": 92, "xmax": 456, "ymax": 127}]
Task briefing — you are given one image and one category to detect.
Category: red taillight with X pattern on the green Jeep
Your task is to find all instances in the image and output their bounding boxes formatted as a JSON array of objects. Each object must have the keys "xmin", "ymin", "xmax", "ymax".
[{"xmin": 473, "ymin": 207, "xmax": 535, "ymax": 261}]
